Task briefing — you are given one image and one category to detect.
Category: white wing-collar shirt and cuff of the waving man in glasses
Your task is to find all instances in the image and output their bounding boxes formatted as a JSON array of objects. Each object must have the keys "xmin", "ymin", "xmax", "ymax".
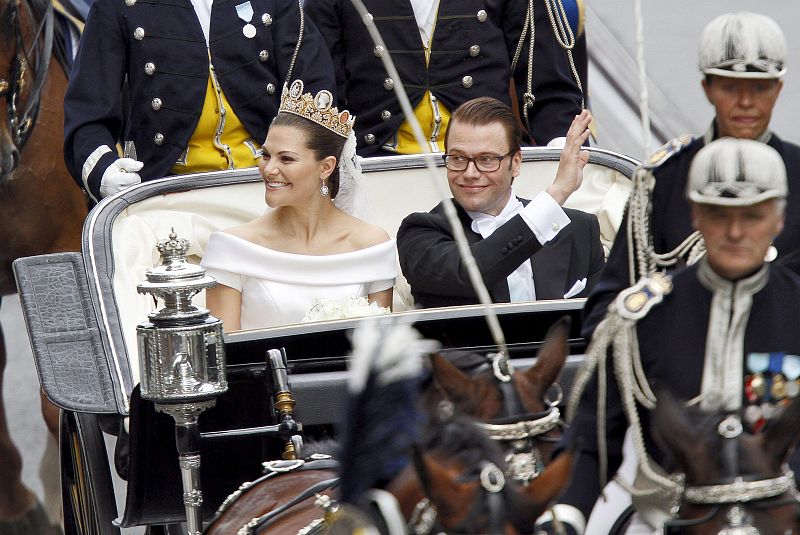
[{"xmin": 467, "ymin": 191, "xmax": 570, "ymax": 302}]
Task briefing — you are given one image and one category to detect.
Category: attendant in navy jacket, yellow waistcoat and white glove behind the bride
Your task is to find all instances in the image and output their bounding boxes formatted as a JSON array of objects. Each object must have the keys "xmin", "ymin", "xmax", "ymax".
[{"xmin": 64, "ymin": 0, "xmax": 335, "ymax": 201}]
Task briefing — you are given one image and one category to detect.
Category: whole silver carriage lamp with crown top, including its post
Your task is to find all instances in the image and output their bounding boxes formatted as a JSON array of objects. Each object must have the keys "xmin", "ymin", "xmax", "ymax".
[{"xmin": 136, "ymin": 229, "xmax": 228, "ymax": 535}]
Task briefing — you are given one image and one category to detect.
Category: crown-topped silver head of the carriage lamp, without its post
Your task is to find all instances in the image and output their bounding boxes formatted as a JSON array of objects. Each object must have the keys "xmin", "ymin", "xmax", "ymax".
[{"xmin": 136, "ymin": 231, "xmax": 228, "ymax": 404}]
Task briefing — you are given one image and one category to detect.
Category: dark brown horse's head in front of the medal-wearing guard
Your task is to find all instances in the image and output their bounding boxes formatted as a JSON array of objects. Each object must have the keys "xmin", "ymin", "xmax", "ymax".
[{"xmin": 652, "ymin": 392, "xmax": 800, "ymax": 535}]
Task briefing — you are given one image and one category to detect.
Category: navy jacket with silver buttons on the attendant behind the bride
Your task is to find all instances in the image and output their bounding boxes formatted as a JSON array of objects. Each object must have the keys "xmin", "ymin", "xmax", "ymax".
[{"xmin": 64, "ymin": 0, "xmax": 335, "ymax": 198}]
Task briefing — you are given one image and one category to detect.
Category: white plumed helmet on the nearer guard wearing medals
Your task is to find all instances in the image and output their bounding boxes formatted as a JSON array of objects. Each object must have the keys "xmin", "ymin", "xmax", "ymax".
[{"xmin": 686, "ymin": 137, "xmax": 787, "ymax": 206}]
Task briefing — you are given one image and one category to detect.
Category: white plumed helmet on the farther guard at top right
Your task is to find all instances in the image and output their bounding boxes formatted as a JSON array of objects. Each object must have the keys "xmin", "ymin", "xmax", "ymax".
[{"xmin": 699, "ymin": 11, "xmax": 787, "ymax": 79}]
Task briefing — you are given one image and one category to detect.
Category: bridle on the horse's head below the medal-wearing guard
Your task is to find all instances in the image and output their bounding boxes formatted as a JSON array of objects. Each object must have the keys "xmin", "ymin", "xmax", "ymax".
[{"xmin": 663, "ymin": 415, "xmax": 800, "ymax": 535}]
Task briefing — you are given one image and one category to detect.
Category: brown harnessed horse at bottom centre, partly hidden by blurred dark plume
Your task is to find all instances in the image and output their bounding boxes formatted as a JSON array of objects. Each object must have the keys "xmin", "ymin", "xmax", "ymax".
[{"xmin": 205, "ymin": 419, "xmax": 573, "ymax": 535}]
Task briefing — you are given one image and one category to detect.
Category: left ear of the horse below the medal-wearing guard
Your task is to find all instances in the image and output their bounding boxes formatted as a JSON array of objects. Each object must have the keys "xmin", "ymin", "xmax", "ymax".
[{"xmin": 650, "ymin": 389, "xmax": 713, "ymax": 483}]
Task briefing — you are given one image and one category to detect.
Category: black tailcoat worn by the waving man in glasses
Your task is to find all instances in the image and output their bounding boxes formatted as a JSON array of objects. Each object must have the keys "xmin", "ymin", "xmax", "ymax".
[{"xmin": 397, "ymin": 199, "xmax": 605, "ymax": 308}]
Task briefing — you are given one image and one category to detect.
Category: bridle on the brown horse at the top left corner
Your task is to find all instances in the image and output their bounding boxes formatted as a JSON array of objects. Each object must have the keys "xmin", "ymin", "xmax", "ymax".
[{"xmin": 0, "ymin": 0, "xmax": 54, "ymax": 153}]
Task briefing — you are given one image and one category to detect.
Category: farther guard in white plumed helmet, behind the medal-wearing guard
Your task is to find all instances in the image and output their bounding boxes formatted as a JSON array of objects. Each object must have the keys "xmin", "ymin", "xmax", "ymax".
[{"xmin": 583, "ymin": 12, "xmax": 800, "ymax": 338}]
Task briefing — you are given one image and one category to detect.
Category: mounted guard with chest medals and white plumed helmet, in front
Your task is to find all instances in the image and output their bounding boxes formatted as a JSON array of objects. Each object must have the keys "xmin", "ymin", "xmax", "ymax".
[{"xmin": 543, "ymin": 138, "xmax": 800, "ymax": 533}]
